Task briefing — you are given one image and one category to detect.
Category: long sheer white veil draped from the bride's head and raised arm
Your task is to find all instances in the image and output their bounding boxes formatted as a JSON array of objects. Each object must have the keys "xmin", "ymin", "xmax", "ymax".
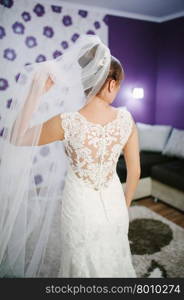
[{"xmin": 0, "ymin": 35, "xmax": 111, "ymax": 277}]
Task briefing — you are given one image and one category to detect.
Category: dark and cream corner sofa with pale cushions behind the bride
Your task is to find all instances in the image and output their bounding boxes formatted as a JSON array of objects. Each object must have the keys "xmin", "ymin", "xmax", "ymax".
[{"xmin": 116, "ymin": 122, "xmax": 184, "ymax": 211}]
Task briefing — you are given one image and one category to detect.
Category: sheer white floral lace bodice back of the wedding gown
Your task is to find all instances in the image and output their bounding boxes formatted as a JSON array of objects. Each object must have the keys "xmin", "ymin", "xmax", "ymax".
[{"xmin": 60, "ymin": 107, "xmax": 133, "ymax": 190}]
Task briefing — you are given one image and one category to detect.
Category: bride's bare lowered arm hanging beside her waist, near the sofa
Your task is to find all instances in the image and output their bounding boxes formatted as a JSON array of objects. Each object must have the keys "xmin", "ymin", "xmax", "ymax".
[{"xmin": 123, "ymin": 120, "xmax": 141, "ymax": 207}]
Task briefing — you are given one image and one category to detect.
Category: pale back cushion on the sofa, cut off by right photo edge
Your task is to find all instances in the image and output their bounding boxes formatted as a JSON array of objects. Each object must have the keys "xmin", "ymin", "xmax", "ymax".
[{"xmin": 162, "ymin": 128, "xmax": 184, "ymax": 158}]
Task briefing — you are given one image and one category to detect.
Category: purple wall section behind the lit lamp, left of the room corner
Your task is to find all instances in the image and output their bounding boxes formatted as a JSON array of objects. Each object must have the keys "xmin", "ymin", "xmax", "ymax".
[{"xmin": 109, "ymin": 16, "xmax": 158, "ymax": 124}]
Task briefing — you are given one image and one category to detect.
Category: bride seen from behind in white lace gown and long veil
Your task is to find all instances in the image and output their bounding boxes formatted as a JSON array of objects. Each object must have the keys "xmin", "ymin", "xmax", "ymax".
[{"xmin": 0, "ymin": 35, "xmax": 140, "ymax": 277}]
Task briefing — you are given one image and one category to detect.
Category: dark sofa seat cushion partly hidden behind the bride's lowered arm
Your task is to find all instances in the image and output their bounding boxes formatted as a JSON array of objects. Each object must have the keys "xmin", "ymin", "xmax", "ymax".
[{"xmin": 116, "ymin": 151, "xmax": 177, "ymax": 182}]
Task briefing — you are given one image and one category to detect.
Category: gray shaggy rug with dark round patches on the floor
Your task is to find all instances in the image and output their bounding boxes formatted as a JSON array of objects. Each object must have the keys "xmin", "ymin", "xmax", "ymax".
[{"xmin": 129, "ymin": 205, "xmax": 184, "ymax": 278}]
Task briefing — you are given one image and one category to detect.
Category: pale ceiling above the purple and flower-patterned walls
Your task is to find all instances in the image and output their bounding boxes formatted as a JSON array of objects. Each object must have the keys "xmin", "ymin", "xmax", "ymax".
[{"xmin": 57, "ymin": 0, "xmax": 184, "ymax": 22}]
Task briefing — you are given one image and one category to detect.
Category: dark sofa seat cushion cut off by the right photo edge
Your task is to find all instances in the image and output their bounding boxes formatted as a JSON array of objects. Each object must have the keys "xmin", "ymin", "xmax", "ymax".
[{"xmin": 151, "ymin": 159, "xmax": 184, "ymax": 191}]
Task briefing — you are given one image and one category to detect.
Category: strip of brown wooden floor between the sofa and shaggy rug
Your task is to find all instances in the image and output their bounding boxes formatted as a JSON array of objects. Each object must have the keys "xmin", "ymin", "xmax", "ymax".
[{"xmin": 133, "ymin": 197, "xmax": 184, "ymax": 228}]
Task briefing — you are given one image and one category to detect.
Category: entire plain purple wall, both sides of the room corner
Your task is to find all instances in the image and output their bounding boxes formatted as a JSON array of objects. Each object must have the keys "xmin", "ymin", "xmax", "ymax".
[{"xmin": 109, "ymin": 16, "xmax": 184, "ymax": 128}]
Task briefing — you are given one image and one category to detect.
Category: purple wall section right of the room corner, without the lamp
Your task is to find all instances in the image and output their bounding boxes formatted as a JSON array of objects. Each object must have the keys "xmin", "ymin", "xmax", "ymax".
[{"xmin": 155, "ymin": 17, "xmax": 184, "ymax": 129}]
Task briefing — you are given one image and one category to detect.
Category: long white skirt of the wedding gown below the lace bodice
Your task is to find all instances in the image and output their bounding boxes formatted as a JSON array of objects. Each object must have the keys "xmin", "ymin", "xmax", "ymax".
[{"xmin": 58, "ymin": 166, "xmax": 137, "ymax": 278}]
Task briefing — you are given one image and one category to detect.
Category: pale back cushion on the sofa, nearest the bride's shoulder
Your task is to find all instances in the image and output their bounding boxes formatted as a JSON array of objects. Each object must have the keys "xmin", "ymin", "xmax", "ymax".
[{"xmin": 136, "ymin": 122, "xmax": 172, "ymax": 152}]
